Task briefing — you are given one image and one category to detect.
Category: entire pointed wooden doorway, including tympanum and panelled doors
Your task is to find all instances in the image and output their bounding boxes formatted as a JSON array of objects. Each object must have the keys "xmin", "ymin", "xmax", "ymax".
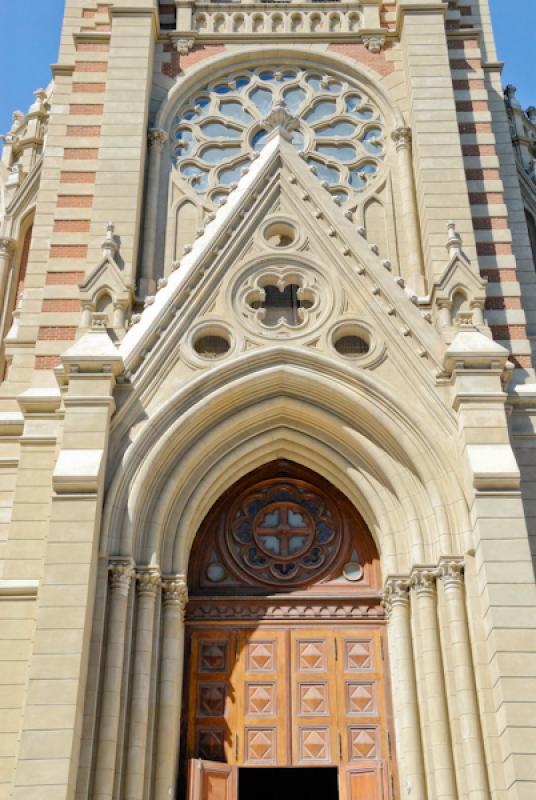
[{"xmin": 180, "ymin": 460, "xmax": 395, "ymax": 800}]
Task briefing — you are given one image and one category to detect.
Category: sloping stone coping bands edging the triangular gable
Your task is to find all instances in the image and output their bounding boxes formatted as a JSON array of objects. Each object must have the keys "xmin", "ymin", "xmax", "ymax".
[{"xmin": 120, "ymin": 131, "xmax": 444, "ymax": 382}]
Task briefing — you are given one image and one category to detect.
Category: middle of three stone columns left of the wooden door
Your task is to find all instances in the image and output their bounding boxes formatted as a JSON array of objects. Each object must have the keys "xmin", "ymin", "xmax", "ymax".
[{"xmin": 125, "ymin": 568, "xmax": 160, "ymax": 800}]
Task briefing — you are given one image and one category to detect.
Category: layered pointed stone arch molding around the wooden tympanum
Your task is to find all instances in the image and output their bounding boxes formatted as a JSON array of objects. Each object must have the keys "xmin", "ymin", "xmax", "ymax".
[{"xmin": 101, "ymin": 347, "xmax": 468, "ymax": 573}]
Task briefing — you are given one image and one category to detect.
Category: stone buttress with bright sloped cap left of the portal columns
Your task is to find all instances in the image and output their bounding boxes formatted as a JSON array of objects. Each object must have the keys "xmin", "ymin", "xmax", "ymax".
[{"xmin": 12, "ymin": 331, "xmax": 122, "ymax": 800}]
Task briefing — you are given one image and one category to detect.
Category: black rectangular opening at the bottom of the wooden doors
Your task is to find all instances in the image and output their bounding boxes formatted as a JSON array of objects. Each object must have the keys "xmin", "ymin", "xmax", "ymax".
[{"xmin": 238, "ymin": 767, "xmax": 339, "ymax": 800}]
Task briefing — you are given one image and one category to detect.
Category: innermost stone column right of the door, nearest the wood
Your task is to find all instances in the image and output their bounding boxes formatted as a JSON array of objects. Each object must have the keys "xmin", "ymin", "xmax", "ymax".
[{"xmin": 384, "ymin": 578, "xmax": 426, "ymax": 800}]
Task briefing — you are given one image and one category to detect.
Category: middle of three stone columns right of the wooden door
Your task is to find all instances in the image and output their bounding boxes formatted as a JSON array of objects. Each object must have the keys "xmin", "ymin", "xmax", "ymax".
[{"xmin": 411, "ymin": 569, "xmax": 458, "ymax": 800}]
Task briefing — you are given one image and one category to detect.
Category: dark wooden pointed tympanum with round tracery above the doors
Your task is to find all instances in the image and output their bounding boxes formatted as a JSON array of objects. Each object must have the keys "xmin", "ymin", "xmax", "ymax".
[{"xmin": 189, "ymin": 461, "xmax": 380, "ymax": 597}]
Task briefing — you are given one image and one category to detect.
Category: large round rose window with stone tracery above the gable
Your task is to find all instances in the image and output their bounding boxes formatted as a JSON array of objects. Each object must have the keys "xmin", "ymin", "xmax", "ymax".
[{"xmin": 173, "ymin": 68, "xmax": 384, "ymax": 206}]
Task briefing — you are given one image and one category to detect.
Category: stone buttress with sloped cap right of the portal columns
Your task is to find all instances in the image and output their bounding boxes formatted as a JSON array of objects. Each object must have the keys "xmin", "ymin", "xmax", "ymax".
[{"xmin": 445, "ymin": 333, "xmax": 536, "ymax": 800}]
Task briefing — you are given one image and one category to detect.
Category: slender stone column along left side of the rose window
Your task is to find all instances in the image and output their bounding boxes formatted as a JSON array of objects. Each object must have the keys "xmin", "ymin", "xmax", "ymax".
[{"xmin": 140, "ymin": 128, "xmax": 168, "ymax": 297}]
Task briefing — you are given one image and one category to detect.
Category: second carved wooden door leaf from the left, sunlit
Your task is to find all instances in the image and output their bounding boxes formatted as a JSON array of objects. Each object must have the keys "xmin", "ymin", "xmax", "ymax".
[{"xmin": 236, "ymin": 628, "xmax": 291, "ymax": 767}]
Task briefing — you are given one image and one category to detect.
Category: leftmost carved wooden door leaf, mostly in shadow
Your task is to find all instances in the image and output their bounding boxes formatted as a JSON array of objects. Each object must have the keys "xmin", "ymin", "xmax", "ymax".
[{"xmin": 187, "ymin": 628, "xmax": 236, "ymax": 764}]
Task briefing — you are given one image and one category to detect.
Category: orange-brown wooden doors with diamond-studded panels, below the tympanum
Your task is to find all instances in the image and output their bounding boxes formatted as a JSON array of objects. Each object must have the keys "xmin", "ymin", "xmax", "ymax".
[{"xmin": 186, "ymin": 622, "xmax": 391, "ymax": 800}]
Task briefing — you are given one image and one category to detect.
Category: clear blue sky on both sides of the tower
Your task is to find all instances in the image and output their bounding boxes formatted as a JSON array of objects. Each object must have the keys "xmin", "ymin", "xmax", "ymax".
[{"xmin": 0, "ymin": 0, "xmax": 536, "ymax": 133}]
